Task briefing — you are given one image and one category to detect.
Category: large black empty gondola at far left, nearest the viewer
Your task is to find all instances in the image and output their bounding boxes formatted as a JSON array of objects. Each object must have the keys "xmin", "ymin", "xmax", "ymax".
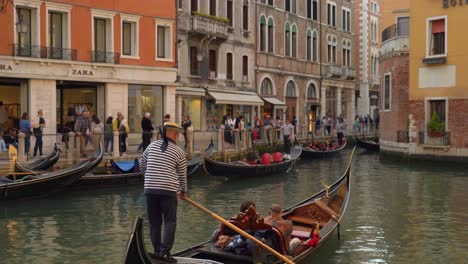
[{"xmin": 0, "ymin": 145, "xmax": 103, "ymax": 201}]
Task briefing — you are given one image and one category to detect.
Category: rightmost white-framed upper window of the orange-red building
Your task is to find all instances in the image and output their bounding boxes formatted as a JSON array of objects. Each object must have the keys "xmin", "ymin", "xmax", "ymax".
[{"xmin": 156, "ymin": 21, "xmax": 173, "ymax": 61}]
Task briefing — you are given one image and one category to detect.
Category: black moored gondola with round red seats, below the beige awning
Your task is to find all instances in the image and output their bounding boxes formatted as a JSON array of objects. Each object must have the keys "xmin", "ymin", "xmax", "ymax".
[{"xmin": 203, "ymin": 142, "xmax": 302, "ymax": 177}]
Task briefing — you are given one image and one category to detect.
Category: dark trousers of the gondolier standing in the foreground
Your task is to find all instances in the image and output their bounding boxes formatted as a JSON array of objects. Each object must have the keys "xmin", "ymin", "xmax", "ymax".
[{"xmin": 146, "ymin": 194, "xmax": 177, "ymax": 254}]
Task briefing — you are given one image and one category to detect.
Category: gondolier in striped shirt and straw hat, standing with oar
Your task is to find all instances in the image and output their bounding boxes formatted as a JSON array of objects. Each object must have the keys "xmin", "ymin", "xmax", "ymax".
[{"xmin": 140, "ymin": 122, "xmax": 187, "ymax": 263}]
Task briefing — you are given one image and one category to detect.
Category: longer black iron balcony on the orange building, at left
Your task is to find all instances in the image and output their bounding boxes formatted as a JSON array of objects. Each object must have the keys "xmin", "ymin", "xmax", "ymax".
[{"xmin": 12, "ymin": 44, "xmax": 77, "ymax": 61}]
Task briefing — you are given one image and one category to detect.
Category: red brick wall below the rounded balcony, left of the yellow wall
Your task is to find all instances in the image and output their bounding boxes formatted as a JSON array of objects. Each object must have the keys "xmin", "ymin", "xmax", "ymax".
[{"xmin": 380, "ymin": 55, "xmax": 408, "ymax": 142}]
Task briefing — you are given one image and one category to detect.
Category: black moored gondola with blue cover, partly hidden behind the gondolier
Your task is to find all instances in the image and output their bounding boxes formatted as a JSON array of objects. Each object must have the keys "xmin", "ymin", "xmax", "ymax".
[{"xmin": 73, "ymin": 140, "xmax": 218, "ymax": 188}]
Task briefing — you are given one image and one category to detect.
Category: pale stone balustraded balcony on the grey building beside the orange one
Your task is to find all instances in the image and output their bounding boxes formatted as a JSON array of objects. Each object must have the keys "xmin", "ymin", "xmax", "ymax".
[{"xmin": 190, "ymin": 15, "xmax": 228, "ymax": 39}]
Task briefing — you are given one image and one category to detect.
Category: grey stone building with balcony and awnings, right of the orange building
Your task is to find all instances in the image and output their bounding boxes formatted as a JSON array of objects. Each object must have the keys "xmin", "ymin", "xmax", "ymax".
[{"xmin": 176, "ymin": 0, "xmax": 263, "ymax": 131}]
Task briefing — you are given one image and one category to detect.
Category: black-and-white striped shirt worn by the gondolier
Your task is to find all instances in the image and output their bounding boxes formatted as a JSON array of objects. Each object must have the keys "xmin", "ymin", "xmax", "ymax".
[{"xmin": 140, "ymin": 139, "xmax": 187, "ymax": 195}]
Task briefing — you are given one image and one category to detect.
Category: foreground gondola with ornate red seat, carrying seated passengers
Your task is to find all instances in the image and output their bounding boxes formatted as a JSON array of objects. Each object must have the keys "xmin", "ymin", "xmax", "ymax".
[{"xmin": 124, "ymin": 147, "xmax": 354, "ymax": 264}]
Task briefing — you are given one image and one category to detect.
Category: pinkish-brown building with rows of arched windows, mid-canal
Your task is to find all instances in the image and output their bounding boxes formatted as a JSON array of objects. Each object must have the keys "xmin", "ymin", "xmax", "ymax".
[{"xmin": 255, "ymin": 0, "xmax": 355, "ymax": 131}]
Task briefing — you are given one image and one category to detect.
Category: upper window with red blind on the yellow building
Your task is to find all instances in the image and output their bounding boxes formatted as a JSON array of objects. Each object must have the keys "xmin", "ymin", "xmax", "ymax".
[{"xmin": 427, "ymin": 18, "xmax": 447, "ymax": 56}]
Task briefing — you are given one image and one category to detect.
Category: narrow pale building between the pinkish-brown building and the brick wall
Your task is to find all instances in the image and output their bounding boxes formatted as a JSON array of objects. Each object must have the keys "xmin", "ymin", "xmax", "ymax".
[{"xmin": 354, "ymin": 0, "xmax": 382, "ymax": 118}]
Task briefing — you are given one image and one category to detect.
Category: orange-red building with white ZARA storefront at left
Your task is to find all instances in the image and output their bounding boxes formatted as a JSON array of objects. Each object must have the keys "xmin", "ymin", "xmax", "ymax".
[{"xmin": 0, "ymin": 0, "xmax": 177, "ymax": 151}]
